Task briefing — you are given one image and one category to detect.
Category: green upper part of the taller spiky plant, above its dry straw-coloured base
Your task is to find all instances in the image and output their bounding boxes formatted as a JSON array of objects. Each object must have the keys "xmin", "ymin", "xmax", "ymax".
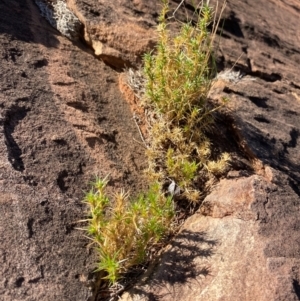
[{"xmin": 144, "ymin": 0, "xmax": 214, "ymax": 125}]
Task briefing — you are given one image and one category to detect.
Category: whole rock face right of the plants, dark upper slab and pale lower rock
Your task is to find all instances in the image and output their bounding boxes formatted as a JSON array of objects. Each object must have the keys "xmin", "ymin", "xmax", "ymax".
[{"xmin": 118, "ymin": 0, "xmax": 300, "ymax": 301}]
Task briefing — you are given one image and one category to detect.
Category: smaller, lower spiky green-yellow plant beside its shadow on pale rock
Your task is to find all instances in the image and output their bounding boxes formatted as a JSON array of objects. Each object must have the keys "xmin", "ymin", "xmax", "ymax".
[{"xmin": 85, "ymin": 178, "xmax": 174, "ymax": 284}]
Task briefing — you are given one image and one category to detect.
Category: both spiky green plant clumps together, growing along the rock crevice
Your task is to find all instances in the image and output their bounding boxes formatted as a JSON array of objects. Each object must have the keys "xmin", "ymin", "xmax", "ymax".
[{"xmin": 85, "ymin": 0, "xmax": 229, "ymax": 284}]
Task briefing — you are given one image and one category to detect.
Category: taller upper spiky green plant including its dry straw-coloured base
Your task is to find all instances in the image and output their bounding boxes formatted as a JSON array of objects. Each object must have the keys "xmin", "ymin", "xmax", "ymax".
[{"xmin": 144, "ymin": 0, "xmax": 229, "ymax": 201}]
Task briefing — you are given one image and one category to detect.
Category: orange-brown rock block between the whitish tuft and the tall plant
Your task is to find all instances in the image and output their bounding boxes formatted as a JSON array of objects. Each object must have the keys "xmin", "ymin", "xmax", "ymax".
[{"xmin": 67, "ymin": 0, "xmax": 155, "ymax": 70}]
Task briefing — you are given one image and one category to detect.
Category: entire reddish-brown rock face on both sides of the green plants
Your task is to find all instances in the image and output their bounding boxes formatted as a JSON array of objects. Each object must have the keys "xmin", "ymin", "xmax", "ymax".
[{"xmin": 0, "ymin": 0, "xmax": 300, "ymax": 301}]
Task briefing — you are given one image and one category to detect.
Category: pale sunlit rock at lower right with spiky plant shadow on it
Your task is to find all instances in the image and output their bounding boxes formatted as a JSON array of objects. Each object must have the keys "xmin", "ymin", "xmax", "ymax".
[{"xmin": 123, "ymin": 168, "xmax": 300, "ymax": 301}]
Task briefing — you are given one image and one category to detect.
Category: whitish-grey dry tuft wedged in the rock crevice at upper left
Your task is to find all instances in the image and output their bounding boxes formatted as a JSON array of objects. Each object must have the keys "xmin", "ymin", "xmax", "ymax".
[{"xmin": 35, "ymin": 0, "xmax": 83, "ymax": 40}]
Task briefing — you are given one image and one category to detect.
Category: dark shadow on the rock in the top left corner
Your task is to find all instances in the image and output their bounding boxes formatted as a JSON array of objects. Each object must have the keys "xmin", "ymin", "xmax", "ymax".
[{"xmin": 0, "ymin": 0, "xmax": 59, "ymax": 47}]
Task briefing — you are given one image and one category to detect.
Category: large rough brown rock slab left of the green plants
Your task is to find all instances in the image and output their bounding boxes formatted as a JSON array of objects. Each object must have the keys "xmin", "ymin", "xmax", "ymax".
[{"xmin": 0, "ymin": 0, "xmax": 145, "ymax": 301}]
